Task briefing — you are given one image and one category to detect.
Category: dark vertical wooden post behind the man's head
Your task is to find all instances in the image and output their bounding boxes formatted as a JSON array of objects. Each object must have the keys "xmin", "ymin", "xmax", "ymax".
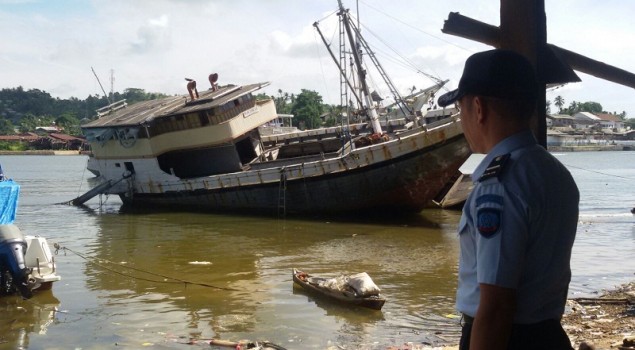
[{"xmin": 500, "ymin": 0, "xmax": 547, "ymax": 147}]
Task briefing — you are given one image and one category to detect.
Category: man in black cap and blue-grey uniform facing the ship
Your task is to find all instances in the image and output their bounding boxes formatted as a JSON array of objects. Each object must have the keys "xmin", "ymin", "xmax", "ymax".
[{"xmin": 438, "ymin": 49, "xmax": 579, "ymax": 350}]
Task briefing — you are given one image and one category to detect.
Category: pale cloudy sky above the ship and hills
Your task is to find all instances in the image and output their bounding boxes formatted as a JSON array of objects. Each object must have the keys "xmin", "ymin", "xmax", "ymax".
[{"xmin": 0, "ymin": 0, "xmax": 635, "ymax": 118}]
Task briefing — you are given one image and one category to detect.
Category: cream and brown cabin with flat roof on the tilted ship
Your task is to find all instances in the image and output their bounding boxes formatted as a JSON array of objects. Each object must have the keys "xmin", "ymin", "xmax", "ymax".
[{"xmin": 82, "ymin": 83, "xmax": 278, "ymax": 178}]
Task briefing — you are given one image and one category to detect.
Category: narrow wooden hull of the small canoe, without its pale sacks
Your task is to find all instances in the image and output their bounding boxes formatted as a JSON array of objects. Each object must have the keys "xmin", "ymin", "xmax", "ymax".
[{"xmin": 293, "ymin": 268, "xmax": 386, "ymax": 310}]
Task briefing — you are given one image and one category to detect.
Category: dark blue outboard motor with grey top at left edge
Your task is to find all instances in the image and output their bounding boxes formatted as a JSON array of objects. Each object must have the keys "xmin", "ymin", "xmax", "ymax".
[{"xmin": 0, "ymin": 225, "xmax": 33, "ymax": 299}]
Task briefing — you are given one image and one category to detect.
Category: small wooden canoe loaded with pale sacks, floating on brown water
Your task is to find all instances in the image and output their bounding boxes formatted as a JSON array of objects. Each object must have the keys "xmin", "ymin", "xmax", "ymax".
[{"xmin": 293, "ymin": 268, "xmax": 386, "ymax": 310}]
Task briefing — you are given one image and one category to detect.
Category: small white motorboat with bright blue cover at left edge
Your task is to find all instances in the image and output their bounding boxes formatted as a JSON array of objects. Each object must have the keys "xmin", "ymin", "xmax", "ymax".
[{"xmin": 0, "ymin": 180, "xmax": 61, "ymax": 299}]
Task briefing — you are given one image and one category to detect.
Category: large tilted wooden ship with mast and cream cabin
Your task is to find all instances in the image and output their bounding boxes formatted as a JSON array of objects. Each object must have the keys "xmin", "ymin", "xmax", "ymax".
[{"xmin": 73, "ymin": 3, "xmax": 470, "ymax": 215}]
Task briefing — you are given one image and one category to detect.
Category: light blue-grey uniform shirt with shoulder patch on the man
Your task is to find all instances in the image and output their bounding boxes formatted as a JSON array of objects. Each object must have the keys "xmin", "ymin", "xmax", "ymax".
[{"xmin": 456, "ymin": 131, "xmax": 579, "ymax": 324}]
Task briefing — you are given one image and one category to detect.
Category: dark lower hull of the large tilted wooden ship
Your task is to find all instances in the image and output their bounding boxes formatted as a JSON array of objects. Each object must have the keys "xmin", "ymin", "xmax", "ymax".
[{"xmin": 121, "ymin": 134, "xmax": 469, "ymax": 214}]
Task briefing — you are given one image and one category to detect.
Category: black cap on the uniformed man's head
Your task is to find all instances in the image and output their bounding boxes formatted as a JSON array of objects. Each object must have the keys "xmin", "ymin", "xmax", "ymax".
[{"xmin": 438, "ymin": 49, "xmax": 537, "ymax": 107}]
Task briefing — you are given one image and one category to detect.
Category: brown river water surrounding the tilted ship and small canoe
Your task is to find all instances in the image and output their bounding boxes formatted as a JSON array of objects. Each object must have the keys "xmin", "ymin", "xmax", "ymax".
[{"xmin": 0, "ymin": 152, "xmax": 635, "ymax": 349}]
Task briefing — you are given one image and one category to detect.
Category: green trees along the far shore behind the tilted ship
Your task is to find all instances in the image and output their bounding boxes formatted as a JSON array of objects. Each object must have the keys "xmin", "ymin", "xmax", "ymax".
[{"xmin": 0, "ymin": 86, "xmax": 635, "ymax": 136}]
